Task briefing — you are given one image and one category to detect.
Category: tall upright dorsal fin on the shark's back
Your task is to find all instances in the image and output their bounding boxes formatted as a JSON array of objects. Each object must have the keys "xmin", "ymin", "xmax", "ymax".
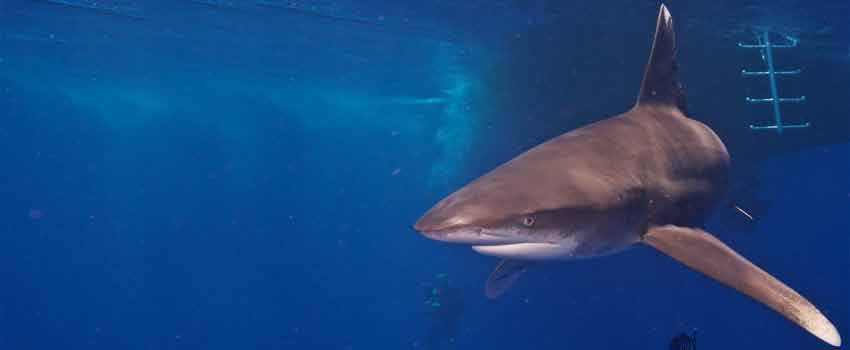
[{"xmin": 637, "ymin": 4, "xmax": 688, "ymax": 115}]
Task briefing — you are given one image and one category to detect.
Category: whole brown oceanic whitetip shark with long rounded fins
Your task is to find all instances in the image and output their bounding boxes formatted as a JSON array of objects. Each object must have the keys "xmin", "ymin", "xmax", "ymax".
[{"xmin": 414, "ymin": 5, "xmax": 841, "ymax": 346}]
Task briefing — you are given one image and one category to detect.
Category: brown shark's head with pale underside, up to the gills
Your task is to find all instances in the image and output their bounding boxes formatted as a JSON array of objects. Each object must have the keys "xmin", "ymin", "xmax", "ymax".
[{"xmin": 414, "ymin": 149, "xmax": 639, "ymax": 260}]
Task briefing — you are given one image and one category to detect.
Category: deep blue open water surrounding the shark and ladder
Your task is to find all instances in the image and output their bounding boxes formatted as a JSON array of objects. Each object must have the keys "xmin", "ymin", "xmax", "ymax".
[{"xmin": 0, "ymin": 0, "xmax": 850, "ymax": 350}]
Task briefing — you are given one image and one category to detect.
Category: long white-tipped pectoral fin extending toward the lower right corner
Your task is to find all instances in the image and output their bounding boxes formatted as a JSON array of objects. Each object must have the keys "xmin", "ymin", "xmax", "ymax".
[{"xmin": 643, "ymin": 226, "xmax": 841, "ymax": 346}]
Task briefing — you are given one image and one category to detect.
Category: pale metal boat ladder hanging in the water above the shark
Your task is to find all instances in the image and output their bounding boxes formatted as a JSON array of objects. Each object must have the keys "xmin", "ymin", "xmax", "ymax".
[{"xmin": 738, "ymin": 29, "xmax": 809, "ymax": 135}]
